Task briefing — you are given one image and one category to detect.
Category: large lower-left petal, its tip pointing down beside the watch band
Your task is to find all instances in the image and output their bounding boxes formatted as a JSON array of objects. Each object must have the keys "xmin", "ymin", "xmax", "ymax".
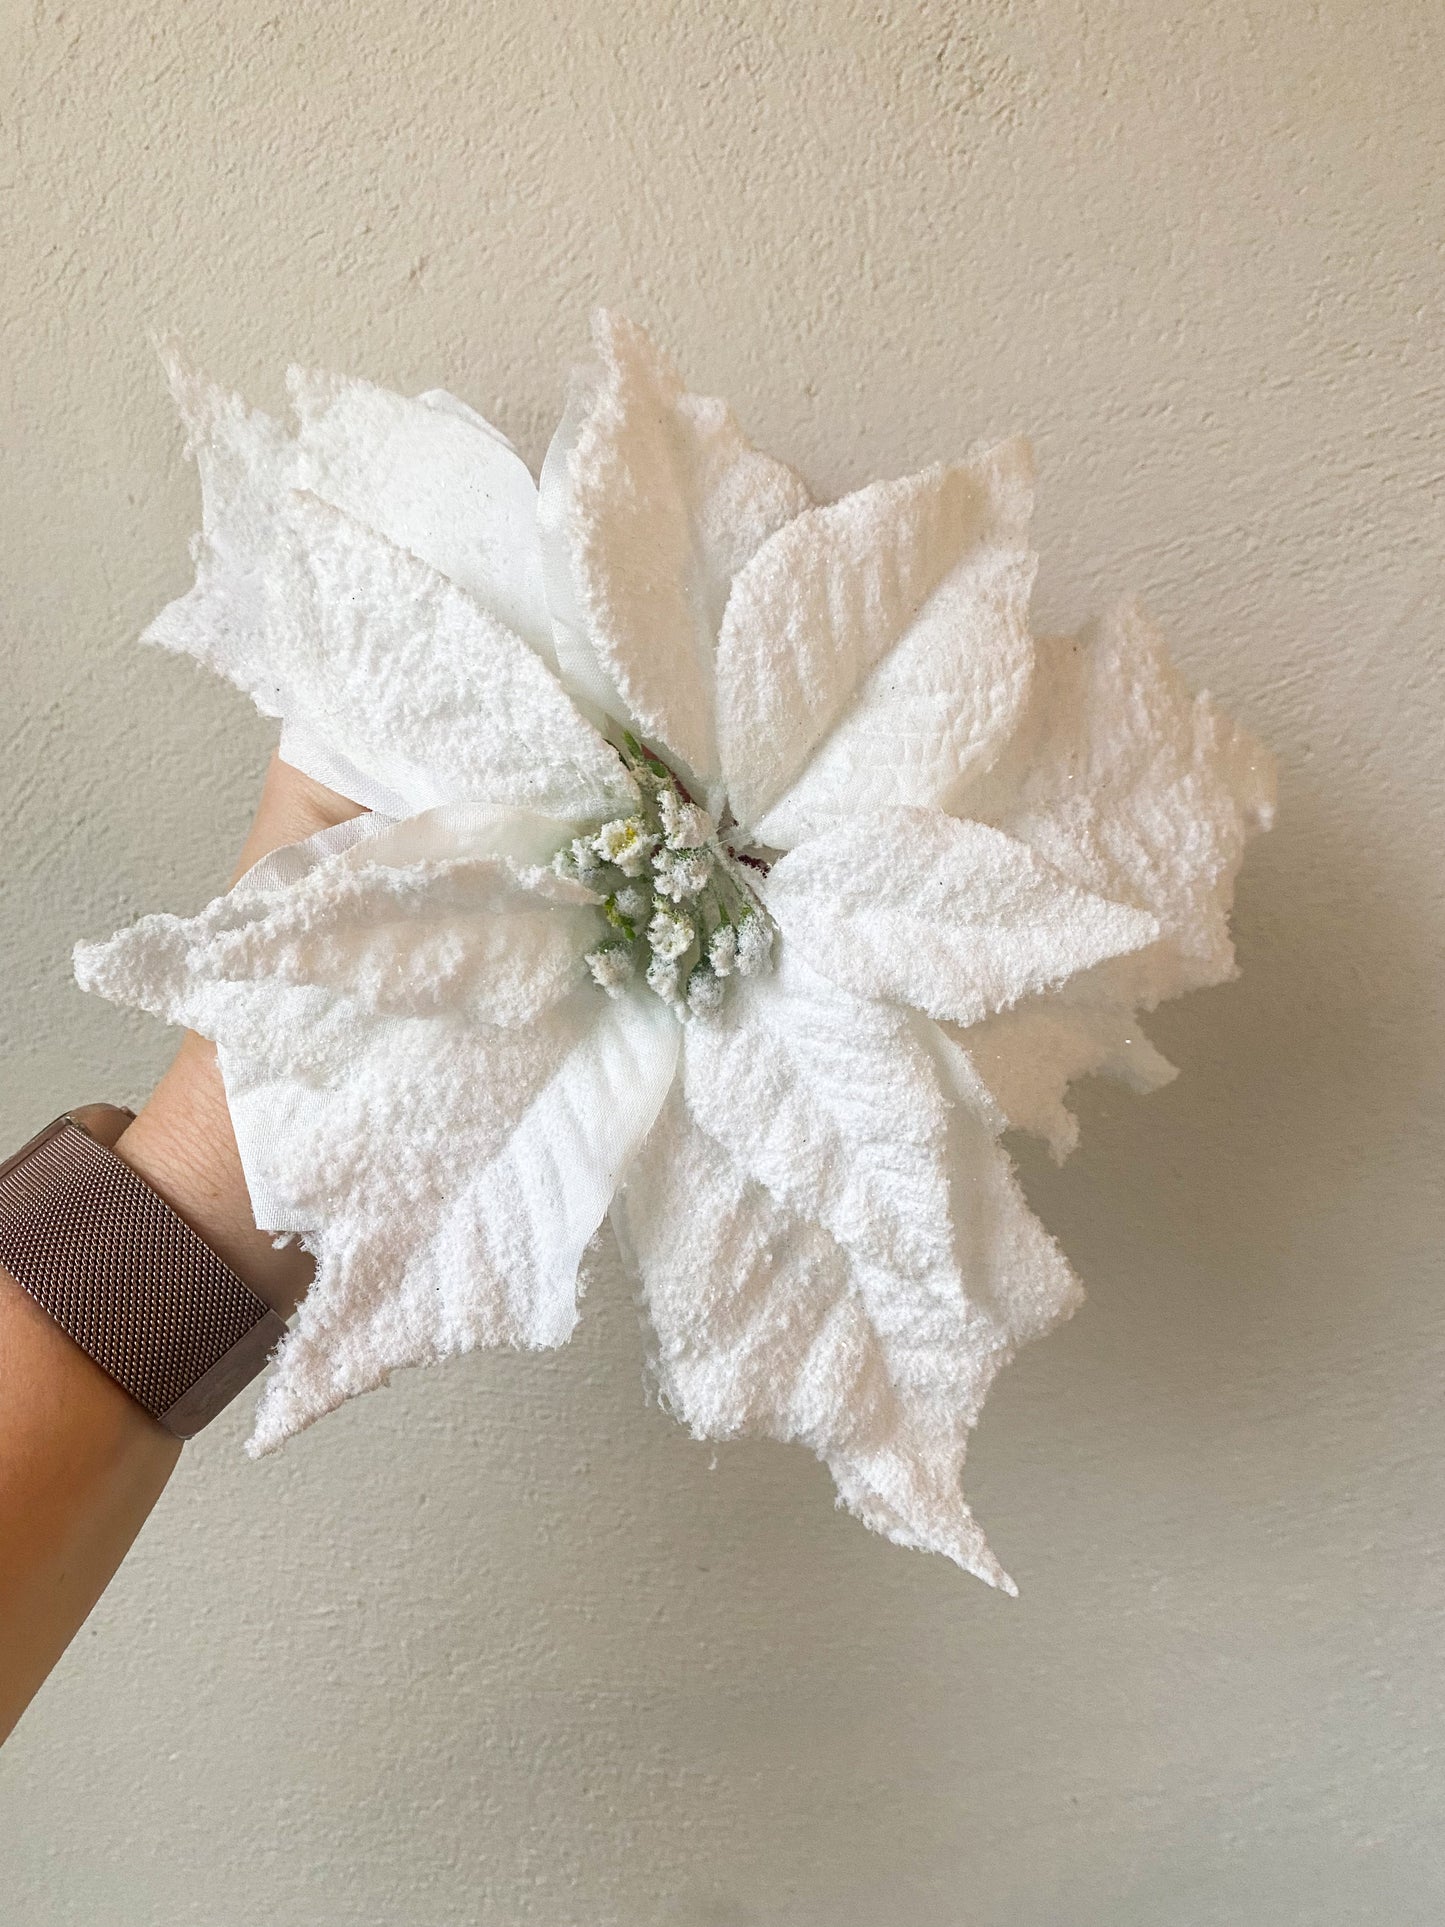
[{"xmin": 249, "ymin": 990, "xmax": 678, "ymax": 1453}]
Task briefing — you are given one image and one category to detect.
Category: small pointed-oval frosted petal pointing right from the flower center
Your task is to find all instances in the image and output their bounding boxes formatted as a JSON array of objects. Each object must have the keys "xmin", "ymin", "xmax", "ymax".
[{"xmin": 763, "ymin": 807, "xmax": 1158, "ymax": 1023}]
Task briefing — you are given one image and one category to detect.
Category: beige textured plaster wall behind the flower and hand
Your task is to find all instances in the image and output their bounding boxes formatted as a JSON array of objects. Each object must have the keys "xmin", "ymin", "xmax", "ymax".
[{"xmin": 0, "ymin": 0, "xmax": 1445, "ymax": 1927}]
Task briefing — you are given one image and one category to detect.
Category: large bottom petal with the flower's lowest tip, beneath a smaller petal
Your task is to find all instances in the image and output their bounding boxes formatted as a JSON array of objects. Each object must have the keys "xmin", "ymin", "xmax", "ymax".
[{"xmin": 613, "ymin": 1063, "xmax": 1079, "ymax": 1592}]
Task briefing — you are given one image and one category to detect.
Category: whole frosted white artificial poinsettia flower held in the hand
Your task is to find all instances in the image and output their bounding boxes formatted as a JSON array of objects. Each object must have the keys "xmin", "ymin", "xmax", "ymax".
[{"xmin": 77, "ymin": 316, "xmax": 1270, "ymax": 1586}]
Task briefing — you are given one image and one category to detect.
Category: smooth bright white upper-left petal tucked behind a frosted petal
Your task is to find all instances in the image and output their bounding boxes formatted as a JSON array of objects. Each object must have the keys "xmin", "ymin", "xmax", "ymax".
[{"xmin": 289, "ymin": 368, "xmax": 555, "ymax": 667}]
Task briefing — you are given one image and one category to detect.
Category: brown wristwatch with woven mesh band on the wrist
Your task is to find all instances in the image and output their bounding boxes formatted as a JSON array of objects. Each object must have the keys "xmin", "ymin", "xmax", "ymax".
[{"xmin": 0, "ymin": 1104, "xmax": 285, "ymax": 1439}]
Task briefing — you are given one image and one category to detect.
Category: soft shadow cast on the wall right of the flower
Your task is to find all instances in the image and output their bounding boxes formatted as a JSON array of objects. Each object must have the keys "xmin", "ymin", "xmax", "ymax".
[{"xmin": 1017, "ymin": 759, "xmax": 1439, "ymax": 1426}]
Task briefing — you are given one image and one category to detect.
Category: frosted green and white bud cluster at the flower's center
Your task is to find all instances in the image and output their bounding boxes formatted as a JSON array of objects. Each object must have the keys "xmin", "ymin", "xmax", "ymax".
[{"xmin": 553, "ymin": 736, "xmax": 773, "ymax": 1017}]
